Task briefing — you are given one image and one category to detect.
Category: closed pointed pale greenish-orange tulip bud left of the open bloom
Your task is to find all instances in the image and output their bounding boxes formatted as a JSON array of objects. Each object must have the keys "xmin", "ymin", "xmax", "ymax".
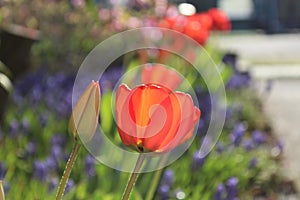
[{"xmin": 69, "ymin": 81, "xmax": 100, "ymax": 141}]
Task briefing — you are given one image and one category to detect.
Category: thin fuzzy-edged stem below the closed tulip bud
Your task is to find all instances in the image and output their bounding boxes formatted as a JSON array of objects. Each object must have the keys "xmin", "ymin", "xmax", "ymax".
[{"xmin": 56, "ymin": 141, "xmax": 80, "ymax": 200}]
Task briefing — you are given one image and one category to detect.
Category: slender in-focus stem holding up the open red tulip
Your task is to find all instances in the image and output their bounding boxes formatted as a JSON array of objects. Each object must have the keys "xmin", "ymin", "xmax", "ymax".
[{"xmin": 122, "ymin": 153, "xmax": 145, "ymax": 200}]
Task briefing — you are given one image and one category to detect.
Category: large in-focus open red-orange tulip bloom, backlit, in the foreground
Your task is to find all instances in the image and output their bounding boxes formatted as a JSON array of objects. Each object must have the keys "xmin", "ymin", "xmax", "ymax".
[{"xmin": 116, "ymin": 83, "xmax": 200, "ymax": 152}]
